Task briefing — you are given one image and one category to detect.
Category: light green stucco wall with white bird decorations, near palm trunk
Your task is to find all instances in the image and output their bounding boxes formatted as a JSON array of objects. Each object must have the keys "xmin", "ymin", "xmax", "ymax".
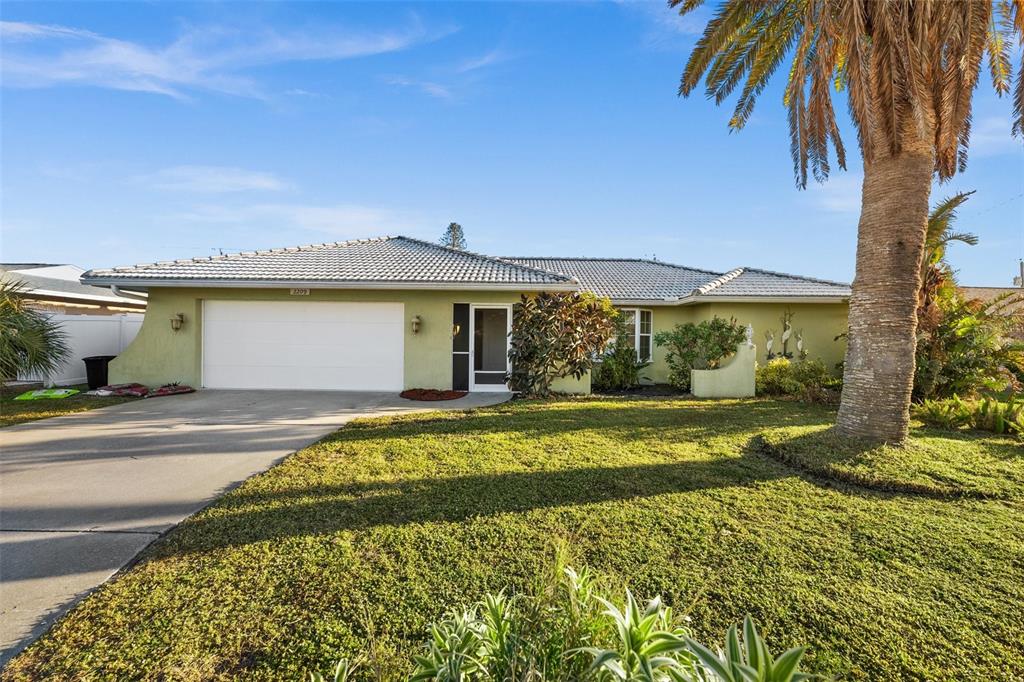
[{"xmin": 641, "ymin": 303, "xmax": 848, "ymax": 383}]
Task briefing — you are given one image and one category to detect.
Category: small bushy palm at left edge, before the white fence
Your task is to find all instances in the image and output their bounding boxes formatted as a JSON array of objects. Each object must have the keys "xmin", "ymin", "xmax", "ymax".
[{"xmin": 0, "ymin": 280, "xmax": 70, "ymax": 381}]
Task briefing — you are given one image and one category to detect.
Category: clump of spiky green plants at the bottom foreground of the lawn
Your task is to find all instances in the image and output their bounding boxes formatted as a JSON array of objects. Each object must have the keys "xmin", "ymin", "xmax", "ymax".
[{"xmin": 310, "ymin": 568, "xmax": 809, "ymax": 682}]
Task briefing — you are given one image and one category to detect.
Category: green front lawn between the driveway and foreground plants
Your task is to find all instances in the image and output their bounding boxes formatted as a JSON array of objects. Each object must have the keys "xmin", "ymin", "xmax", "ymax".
[{"xmin": 6, "ymin": 398, "xmax": 1024, "ymax": 680}]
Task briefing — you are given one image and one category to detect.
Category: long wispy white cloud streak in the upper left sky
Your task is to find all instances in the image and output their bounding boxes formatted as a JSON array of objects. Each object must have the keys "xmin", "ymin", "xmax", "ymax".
[{"xmin": 0, "ymin": 17, "xmax": 455, "ymax": 98}]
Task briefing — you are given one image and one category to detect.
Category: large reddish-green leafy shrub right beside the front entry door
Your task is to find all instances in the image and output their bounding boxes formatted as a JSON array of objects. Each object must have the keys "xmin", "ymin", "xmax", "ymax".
[{"xmin": 509, "ymin": 292, "xmax": 616, "ymax": 396}]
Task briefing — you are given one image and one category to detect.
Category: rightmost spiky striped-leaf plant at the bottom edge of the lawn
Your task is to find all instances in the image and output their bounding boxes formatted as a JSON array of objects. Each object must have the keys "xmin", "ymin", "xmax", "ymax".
[{"xmin": 686, "ymin": 615, "xmax": 811, "ymax": 682}]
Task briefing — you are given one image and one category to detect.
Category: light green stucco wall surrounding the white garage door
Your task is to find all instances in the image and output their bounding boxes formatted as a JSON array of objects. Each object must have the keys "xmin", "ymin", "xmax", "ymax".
[{"xmin": 110, "ymin": 288, "xmax": 590, "ymax": 393}]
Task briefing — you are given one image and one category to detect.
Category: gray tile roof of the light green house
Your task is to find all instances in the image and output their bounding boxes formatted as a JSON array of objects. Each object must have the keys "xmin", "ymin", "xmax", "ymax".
[{"xmin": 82, "ymin": 237, "xmax": 850, "ymax": 303}]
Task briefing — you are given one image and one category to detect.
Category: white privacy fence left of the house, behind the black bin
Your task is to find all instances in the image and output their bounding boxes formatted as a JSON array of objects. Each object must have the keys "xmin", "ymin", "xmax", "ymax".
[{"xmin": 18, "ymin": 312, "xmax": 144, "ymax": 386}]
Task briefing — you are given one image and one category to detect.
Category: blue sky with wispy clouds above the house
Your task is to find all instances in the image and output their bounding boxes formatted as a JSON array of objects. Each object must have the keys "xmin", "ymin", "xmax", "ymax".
[{"xmin": 0, "ymin": 2, "xmax": 1024, "ymax": 286}]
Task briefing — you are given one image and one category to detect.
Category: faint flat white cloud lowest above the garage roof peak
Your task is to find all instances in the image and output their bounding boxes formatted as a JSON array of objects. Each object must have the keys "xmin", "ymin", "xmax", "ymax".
[{"xmin": 173, "ymin": 203, "xmax": 441, "ymax": 239}]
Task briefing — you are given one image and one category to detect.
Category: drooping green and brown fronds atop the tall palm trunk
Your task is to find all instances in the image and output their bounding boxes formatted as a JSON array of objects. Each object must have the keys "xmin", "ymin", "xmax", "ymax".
[{"xmin": 670, "ymin": 0, "xmax": 1024, "ymax": 187}]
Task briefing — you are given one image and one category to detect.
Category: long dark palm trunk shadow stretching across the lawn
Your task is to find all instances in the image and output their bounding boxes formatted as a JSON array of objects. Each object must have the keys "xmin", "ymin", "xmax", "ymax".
[{"xmin": 154, "ymin": 457, "xmax": 794, "ymax": 556}]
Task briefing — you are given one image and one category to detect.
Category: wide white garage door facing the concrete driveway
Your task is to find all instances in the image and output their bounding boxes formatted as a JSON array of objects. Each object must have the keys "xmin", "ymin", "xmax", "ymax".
[{"xmin": 203, "ymin": 301, "xmax": 404, "ymax": 391}]
